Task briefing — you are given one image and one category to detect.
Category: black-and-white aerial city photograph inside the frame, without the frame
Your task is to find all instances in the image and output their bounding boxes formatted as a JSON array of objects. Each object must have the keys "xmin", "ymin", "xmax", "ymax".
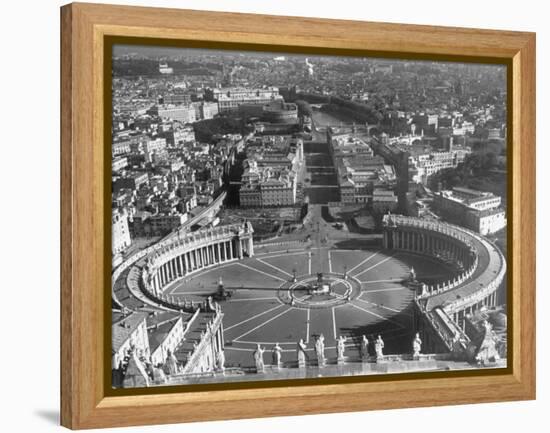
[{"xmin": 110, "ymin": 45, "xmax": 509, "ymax": 388}]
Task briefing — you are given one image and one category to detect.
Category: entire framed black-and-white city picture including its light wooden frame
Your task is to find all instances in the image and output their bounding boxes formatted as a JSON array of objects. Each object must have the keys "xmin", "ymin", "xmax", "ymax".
[{"xmin": 61, "ymin": 4, "xmax": 535, "ymax": 429}]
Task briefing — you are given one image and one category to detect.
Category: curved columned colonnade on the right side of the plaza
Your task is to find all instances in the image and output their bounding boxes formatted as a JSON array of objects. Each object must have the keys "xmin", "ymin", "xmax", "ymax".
[{"xmin": 383, "ymin": 214, "xmax": 506, "ymax": 351}]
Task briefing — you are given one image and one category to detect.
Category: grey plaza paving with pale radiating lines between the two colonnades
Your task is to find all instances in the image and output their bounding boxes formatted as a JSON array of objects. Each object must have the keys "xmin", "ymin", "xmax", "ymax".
[{"xmin": 166, "ymin": 241, "xmax": 449, "ymax": 367}]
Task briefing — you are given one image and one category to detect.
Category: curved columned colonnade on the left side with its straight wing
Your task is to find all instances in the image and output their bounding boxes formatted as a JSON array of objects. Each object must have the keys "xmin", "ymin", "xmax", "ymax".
[{"xmin": 111, "ymin": 223, "xmax": 254, "ymax": 381}]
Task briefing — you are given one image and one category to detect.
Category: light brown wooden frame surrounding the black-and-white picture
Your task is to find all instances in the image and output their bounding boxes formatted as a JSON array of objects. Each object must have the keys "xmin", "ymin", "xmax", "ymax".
[{"xmin": 61, "ymin": 3, "xmax": 535, "ymax": 429}]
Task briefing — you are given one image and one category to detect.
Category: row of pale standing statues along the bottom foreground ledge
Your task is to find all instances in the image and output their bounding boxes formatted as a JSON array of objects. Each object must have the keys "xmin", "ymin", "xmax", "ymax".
[{"xmin": 252, "ymin": 333, "xmax": 422, "ymax": 372}]
